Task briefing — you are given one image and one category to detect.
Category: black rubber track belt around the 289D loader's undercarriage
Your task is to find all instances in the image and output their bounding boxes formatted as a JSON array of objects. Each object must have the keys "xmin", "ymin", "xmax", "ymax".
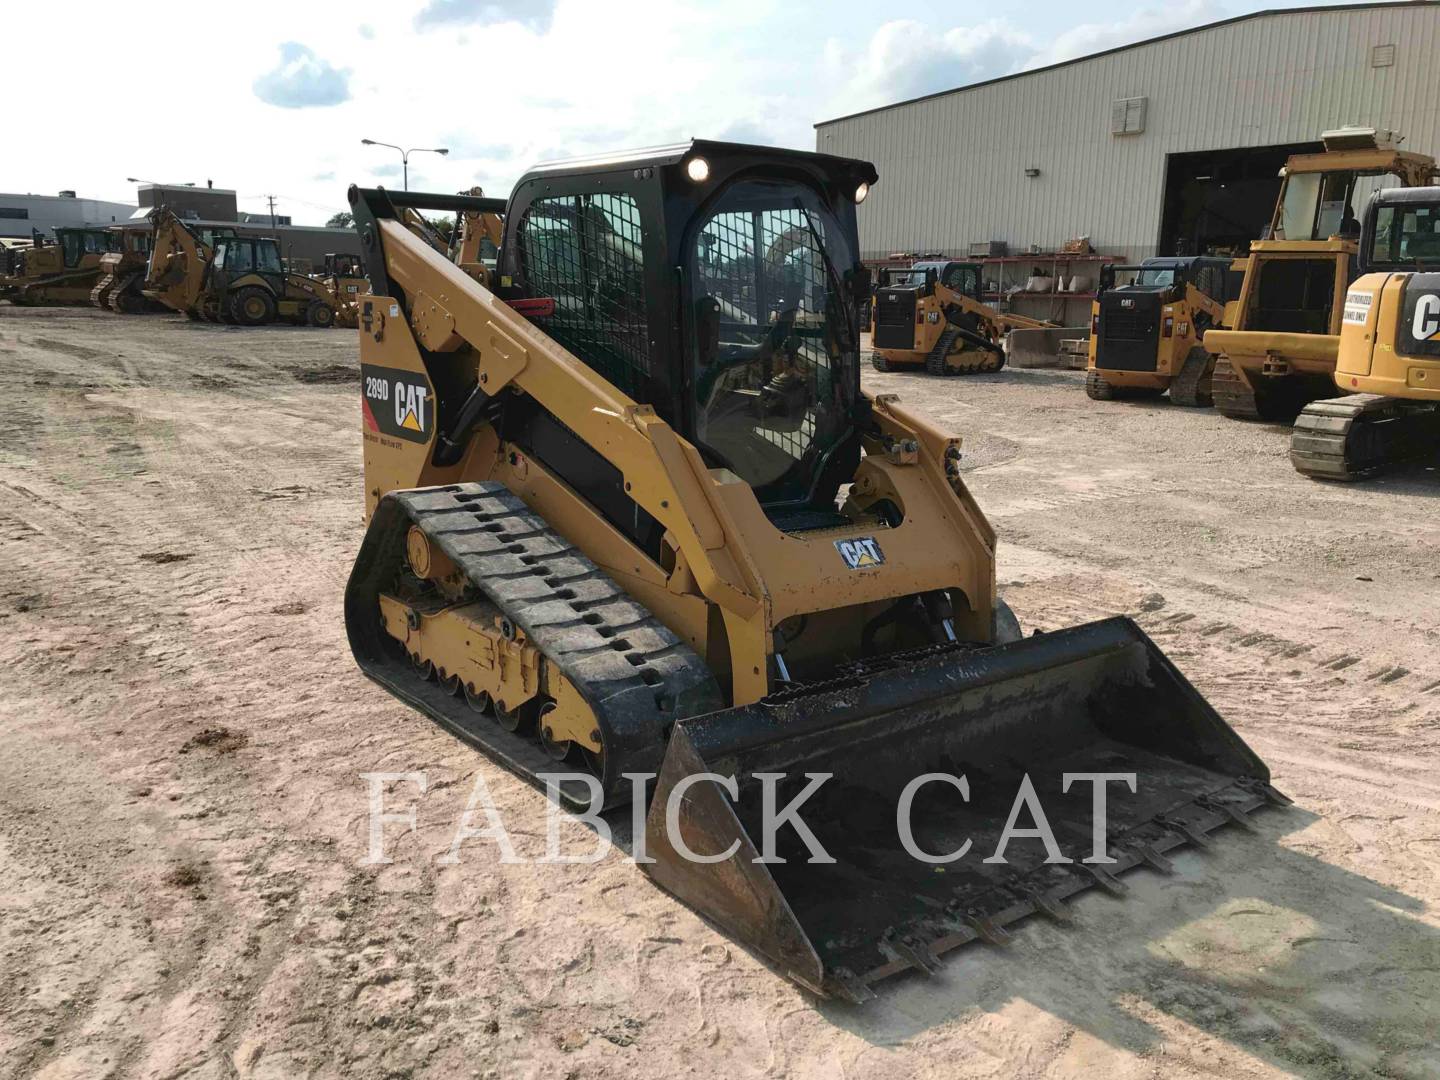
[{"xmin": 346, "ymin": 482, "xmax": 724, "ymax": 809}]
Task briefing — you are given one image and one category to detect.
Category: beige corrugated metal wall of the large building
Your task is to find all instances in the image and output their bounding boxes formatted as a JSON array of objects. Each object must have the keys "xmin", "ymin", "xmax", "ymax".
[{"xmin": 815, "ymin": 4, "xmax": 1440, "ymax": 258}]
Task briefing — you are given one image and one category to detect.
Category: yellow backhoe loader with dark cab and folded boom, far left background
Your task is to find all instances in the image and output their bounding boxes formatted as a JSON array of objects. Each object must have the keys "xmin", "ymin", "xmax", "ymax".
[{"xmin": 145, "ymin": 212, "xmax": 340, "ymax": 327}]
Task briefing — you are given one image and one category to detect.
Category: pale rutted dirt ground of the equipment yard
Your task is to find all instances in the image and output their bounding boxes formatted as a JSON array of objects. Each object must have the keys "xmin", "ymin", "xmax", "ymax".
[{"xmin": 0, "ymin": 307, "xmax": 1440, "ymax": 1080}]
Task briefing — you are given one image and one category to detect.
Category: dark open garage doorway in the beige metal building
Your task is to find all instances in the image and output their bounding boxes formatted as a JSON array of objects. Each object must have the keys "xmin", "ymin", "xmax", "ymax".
[{"xmin": 1158, "ymin": 143, "xmax": 1323, "ymax": 255}]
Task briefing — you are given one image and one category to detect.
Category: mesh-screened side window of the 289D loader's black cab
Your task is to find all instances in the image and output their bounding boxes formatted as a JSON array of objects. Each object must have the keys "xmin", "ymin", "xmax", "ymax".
[{"xmin": 518, "ymin": 193, "xmax": 651, "ymax": 400}]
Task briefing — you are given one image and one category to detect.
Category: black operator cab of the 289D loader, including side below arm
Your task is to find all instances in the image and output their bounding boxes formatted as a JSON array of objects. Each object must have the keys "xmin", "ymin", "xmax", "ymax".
[{"xmin": 495, "ymin": 141, "xmax": 877, "ymax": 550}]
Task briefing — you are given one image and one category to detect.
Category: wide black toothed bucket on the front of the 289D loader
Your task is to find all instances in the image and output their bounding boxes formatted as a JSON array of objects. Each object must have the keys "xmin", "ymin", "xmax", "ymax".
[{"xmin": 645, "ymin": 619, "xmax": 1287, "ymax": 1001}]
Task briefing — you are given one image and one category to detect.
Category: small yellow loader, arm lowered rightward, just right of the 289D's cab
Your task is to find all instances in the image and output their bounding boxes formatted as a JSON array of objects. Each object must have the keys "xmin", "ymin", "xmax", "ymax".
[{"xmin": 870, "ymin": 262, "xmax": 1056, "ymax": 374}]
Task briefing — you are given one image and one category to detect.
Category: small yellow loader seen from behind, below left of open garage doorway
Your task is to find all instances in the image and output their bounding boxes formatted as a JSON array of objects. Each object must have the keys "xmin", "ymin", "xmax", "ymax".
[{"xmin": 1084, "ymin": 256, "xmax": 1246, "ymax": 408}]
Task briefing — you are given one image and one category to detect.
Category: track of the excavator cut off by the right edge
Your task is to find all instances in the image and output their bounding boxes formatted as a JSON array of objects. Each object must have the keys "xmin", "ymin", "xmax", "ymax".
[{"xmin": 1290, "ymin": 393, "xmax": 1440, "ymax": 481}]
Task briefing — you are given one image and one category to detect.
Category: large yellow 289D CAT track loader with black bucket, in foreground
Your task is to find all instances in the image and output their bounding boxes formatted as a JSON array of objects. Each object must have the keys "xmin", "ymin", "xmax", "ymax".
[{"xmin": 344, "ymin": 141, "xmax": 1284, "ymax": 1001}]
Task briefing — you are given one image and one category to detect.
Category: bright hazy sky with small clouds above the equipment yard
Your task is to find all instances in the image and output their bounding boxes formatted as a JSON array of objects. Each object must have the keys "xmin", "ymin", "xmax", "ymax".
[{"xmin": 8, "ymin": 0, "xmax": 1382, "ymax": 225}]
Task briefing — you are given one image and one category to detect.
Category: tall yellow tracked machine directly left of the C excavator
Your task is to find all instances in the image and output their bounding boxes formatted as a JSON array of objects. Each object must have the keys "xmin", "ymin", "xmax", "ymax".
[{"xmin": 1204, "ymin": 128, "xmax": 1436, "ymax": 420}]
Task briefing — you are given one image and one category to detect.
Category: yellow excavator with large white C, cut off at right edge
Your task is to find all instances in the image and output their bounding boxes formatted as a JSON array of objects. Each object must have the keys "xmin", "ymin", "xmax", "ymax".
[{"xmin": 1290, "ymin": 187, "xmax": 1440, "ymax": 480}]
